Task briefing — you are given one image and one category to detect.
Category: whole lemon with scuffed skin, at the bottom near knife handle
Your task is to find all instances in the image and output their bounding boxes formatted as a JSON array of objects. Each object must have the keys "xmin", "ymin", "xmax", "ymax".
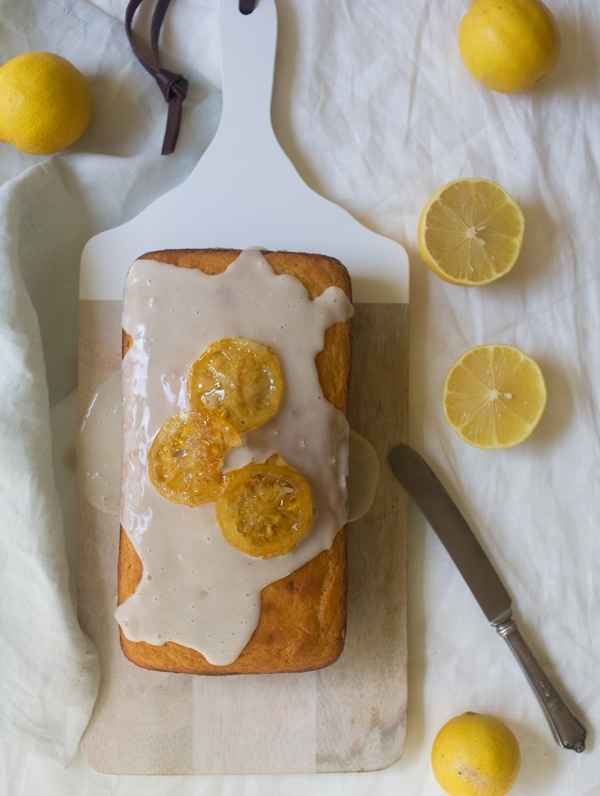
[{"xmin": 431, "ymin": 712, "xmax": 521, "ymax": 796}]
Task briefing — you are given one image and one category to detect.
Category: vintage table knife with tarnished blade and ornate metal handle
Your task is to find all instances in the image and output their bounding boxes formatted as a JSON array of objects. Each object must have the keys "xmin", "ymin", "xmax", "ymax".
[{"xmin": 388, "ymin": 444, "xmax": 587, "ymax": 752}]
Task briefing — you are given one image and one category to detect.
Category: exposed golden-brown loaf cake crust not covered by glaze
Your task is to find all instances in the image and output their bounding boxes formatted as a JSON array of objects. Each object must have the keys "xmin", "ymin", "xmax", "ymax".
[{"xmin": 118, "ymin": 249, "xmax": 351, "ymax": 675}]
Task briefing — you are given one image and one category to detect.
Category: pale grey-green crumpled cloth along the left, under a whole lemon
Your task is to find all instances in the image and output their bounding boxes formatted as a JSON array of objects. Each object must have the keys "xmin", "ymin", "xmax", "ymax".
[{"xmin": 0, "ymin": 0, "xmax": 220, "ymax": 767}]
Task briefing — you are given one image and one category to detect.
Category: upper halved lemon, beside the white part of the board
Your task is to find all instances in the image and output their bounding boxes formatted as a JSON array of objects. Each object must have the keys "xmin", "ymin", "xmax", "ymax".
[{"xmin": 418, "ymin": 177, "xmax": 525, "ymax": 287}]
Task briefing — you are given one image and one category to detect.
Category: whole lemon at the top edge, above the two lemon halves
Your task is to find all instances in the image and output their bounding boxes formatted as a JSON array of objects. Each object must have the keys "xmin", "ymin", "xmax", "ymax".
[{"xmin": 458, "ymin": 0, "xmax": 560, "ymax": 94}]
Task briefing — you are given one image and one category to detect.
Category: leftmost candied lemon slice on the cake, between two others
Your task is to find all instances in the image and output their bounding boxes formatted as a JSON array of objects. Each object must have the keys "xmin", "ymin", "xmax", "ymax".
[{"xmin": 148, "ymin": 411, "xmax": 242, "ymax": 506}]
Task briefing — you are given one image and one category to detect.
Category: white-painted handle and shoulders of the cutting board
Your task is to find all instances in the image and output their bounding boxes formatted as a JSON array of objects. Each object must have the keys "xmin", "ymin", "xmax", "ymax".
[{"xmin": 80, "ymin": 0, "xmax": 408, "ymax": 304}]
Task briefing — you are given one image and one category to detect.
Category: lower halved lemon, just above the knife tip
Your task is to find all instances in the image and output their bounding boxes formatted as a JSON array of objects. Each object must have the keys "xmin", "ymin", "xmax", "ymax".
[{"xmin": 442, "ymin": 344, "xmax": 547, "ymax": 450}]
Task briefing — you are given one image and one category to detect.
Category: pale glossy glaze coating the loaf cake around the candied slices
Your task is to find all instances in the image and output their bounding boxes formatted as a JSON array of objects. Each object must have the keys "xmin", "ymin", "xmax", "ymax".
[{"xmin": 116, "ymin": 249, "xmax": 352, "ymax": 665}]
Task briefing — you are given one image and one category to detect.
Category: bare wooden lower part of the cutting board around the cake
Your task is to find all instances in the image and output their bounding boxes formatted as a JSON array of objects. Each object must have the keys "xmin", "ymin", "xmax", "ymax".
[{"xmin": 78, "ymin": 300, "xmax": 408, "ymax": 775}]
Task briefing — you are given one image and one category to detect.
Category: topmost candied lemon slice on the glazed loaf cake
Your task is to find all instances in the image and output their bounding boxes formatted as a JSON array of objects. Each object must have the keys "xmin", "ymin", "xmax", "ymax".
[{"xmin": 187, "ymin": 337, "xmax": 283, "ymax": 432}]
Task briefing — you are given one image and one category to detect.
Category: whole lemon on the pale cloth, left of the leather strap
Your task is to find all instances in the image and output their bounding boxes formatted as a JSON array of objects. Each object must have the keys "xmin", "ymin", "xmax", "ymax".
[{"xmin": 0, "ymin": 52, "xmax": 93, "ymax": 155}]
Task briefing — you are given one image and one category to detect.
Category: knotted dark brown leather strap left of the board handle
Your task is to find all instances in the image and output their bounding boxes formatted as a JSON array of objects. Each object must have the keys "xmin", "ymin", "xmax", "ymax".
[{"xmin": 125, "ymin": 0, "xmax": 189, "ymax": 155}]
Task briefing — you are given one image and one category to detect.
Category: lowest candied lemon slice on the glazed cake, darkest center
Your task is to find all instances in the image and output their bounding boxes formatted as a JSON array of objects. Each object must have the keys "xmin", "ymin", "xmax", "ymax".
[{"xmin": 216, "ymin": 462, "xmax": 313, "ymax": 558}]
